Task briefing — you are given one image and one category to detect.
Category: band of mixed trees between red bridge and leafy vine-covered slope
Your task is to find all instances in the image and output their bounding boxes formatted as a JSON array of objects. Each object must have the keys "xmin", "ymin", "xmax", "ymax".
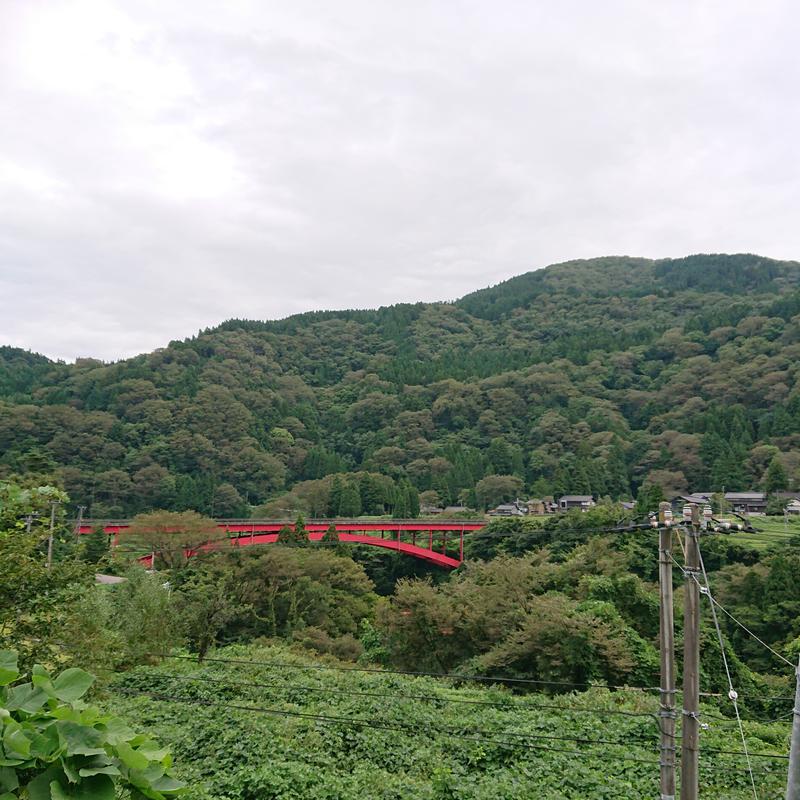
[{"xmin": 10, "ymin": 478, "xmax": 800, "ymax": 710}]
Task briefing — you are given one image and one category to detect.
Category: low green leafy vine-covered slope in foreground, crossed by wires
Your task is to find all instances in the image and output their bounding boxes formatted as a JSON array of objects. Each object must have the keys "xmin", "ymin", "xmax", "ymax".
[{"xmin": 108, "ymin": 645, "xmax": 789, "ymax": 800}]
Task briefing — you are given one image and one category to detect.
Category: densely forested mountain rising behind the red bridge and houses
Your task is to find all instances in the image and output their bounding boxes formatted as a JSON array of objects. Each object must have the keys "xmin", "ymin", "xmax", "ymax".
[{"xmin": 0, "ymin": 255, "xmax": 800, "ymax": 516}]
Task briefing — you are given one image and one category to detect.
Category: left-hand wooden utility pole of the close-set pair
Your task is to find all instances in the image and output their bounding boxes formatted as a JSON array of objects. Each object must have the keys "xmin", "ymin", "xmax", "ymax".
[{"xmin": 658, "ymin": 503, "xmax": 676, "ymax": 800}]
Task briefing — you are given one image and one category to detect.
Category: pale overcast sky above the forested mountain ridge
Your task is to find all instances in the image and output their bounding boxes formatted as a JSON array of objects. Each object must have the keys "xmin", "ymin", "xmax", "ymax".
[{"xmin": 0, "ymin": 0, "xmax": 800, "ymax": 360}]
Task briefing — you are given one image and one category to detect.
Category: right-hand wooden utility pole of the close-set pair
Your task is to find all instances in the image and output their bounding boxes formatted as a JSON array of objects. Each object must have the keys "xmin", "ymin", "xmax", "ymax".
[{"xmin": 681, "ymin": 503, "xmax": 700, "ymax": 800}]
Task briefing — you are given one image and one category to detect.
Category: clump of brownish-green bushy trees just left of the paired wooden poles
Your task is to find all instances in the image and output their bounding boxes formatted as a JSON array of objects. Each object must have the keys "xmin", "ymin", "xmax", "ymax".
[{"xmin": 376, "ymin": 537, "xmax": 658, "ymax": 683}]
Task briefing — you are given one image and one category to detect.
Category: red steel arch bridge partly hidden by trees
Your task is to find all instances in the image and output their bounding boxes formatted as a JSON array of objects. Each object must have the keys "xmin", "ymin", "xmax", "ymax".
[{"xmin": 78, "ymin": 519, "xmax": 486, "ymax": 569}]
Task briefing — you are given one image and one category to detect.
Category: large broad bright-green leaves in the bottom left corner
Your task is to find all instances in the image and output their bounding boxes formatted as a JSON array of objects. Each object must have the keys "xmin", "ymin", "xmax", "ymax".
[{"xmin": 0, "ymin": 650, "xmax": 186, "ymax": 800}]
